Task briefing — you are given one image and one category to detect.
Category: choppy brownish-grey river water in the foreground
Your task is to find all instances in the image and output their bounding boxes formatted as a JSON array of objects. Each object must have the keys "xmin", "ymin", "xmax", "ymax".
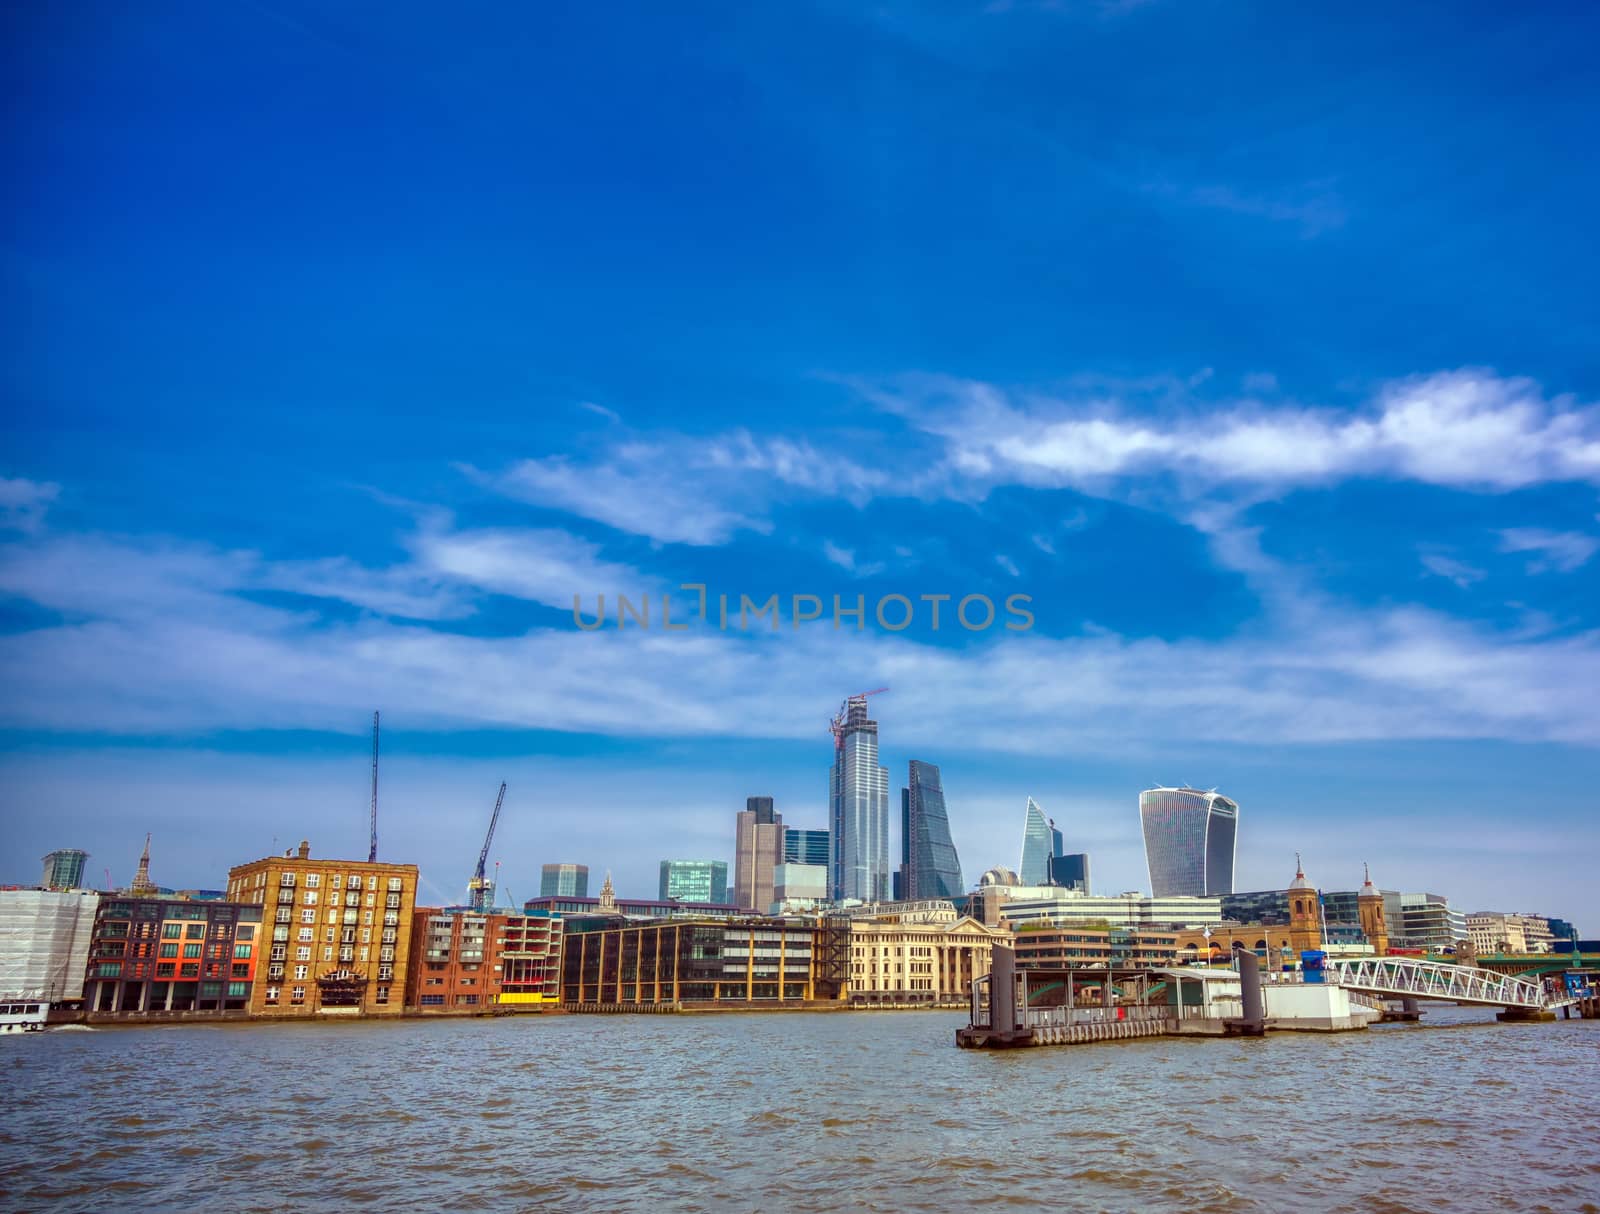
[{"xmin": 0, "ymin": 1008, "xmax": 1600, "ymax": 1214}]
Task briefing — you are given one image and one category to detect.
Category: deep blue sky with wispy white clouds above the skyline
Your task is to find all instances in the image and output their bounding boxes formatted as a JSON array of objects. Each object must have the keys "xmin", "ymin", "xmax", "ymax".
[{"xmin": 0, "ymin": 0, "xmax": 1600, "ymax": 932}]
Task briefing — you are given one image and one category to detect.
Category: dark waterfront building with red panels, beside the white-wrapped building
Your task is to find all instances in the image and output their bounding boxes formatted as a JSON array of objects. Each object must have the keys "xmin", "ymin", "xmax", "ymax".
[{"xmin": 83, "ymin": 896, "xmax": 264, "ymax": 1019}]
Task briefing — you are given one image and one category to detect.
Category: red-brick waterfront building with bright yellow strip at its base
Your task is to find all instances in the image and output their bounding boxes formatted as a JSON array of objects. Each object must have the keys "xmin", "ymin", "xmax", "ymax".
[{"xmin": 405, "ymin": 907, "xmax": 563, "ymax": 1014}]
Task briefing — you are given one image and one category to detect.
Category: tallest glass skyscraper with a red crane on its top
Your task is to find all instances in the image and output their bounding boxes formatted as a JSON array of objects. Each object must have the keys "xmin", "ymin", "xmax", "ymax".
[{"xmin": 827, "ymin": 696, "xmax": 890, "ymax": 902}]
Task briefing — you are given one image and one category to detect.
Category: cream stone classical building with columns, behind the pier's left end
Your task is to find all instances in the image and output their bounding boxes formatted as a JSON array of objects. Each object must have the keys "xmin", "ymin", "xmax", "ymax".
[{"xmin": 846, "ymin": 902, "xmax": 1011, "ymax": 1004}]
